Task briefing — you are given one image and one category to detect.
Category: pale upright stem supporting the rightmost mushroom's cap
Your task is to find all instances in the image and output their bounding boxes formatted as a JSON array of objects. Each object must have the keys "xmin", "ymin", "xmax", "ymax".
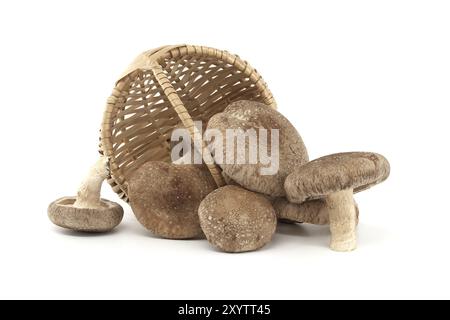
[{"xmin": 325, "ymin": 189, "xmax": 357, "ymax": 252}]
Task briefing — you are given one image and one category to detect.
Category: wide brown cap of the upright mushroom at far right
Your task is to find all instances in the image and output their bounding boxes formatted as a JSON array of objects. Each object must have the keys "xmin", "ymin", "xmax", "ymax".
[{"xmin": 284, "ymin": 152, "xmax": 390, "ymax": 203}]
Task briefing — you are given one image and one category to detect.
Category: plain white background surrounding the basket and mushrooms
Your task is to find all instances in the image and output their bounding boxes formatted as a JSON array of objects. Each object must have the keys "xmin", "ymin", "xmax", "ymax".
[{"xmin": 0, "ymin": 0, "xmax": 450, "ymax": 299}]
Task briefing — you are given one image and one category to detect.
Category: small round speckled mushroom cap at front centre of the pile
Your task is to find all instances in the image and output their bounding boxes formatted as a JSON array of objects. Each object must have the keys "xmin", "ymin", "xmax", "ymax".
[{"xmin": 198, "ymin": 186, "xmax": 277, "ymax": 252}]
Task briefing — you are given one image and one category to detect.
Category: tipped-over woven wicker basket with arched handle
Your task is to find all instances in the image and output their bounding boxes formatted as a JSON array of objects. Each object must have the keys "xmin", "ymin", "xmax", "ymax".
[{"xmin": 100, "ymin": 45, "xmax": 276, "ymax": 201}]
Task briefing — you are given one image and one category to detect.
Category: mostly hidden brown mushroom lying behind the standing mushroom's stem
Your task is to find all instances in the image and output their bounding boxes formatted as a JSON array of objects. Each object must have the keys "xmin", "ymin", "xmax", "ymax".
[{"xmin": 272, "ymin": 198, "xmax": 359, "ymax": 225}]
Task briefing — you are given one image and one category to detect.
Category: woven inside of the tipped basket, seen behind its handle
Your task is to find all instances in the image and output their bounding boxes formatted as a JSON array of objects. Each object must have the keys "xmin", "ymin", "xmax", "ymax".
[{"xmin": 110, "ymin": 55, "xmax": 264, "ymax": 196}]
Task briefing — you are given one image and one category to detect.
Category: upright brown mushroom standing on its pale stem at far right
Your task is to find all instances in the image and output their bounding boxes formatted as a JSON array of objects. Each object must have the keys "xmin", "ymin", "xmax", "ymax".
[{"xmin": 284, "ymin": 152, "xmax": 390, "ymax": 251}]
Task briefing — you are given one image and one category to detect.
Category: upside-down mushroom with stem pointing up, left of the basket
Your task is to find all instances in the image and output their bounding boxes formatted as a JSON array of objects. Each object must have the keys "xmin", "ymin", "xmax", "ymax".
[{"xmin": 48, "ymin": 156, "xmax": 123, "ymax": 232}]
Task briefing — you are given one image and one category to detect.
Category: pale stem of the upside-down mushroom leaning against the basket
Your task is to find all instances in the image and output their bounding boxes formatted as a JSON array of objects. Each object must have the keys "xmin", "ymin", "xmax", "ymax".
[{"xmin": 73, "ymin": 156, "xmax": 108, "ymax": 209}]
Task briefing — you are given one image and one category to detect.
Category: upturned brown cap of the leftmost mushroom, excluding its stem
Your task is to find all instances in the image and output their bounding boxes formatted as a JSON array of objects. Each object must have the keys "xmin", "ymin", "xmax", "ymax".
[{"xmin": 48, "ymin": 197, "xmax": 123, "ymax": 232}]
